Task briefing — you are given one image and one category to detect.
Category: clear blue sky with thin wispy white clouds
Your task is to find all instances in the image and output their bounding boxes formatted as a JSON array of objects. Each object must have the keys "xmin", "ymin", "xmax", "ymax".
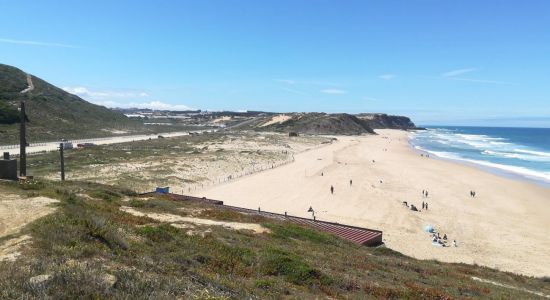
[{"xmin": 0, "ymin": 0, "xmax": 550, "ymax": 127}]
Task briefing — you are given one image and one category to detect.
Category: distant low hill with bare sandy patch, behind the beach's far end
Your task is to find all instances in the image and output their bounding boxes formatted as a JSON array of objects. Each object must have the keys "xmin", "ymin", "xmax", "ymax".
[{"xmin": 254, "ymin": 113, "xmax": 374, "ymax": 135}]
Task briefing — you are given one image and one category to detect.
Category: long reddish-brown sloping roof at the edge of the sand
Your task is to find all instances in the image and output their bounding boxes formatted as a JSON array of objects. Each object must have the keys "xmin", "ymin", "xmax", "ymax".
[{"xmin": 142, "ymin": 193, "xmax": 383, "ymax": 247}]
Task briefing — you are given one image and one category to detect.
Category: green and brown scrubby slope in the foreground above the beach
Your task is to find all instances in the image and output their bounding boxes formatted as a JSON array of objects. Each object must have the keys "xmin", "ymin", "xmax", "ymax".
[{"xmin": 0, "ymin": 181, "xmax": 550, "ymax": 299}]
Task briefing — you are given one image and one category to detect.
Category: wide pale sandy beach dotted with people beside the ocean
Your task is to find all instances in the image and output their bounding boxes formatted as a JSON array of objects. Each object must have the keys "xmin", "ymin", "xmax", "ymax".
[{"xmin": 195, "ymin": 130, "xmax": 550, "ymax": 276}]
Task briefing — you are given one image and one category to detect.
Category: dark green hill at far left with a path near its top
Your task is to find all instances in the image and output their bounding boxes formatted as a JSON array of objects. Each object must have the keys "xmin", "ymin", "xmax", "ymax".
[{"xmin": 0, "ymin": 64, "xmax": 141, "ymax": 143}]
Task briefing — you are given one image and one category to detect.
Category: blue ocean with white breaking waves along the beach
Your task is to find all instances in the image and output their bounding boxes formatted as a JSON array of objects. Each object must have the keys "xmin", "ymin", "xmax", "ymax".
[{"xmin": 411, "ymin": 126, "xmax": 550, "ymax": 186}]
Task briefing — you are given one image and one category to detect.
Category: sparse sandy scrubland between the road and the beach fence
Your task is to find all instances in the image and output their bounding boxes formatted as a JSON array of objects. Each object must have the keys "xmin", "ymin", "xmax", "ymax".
[{"xmin": 28, "ymin": 132, "xmax": 329, "ymax": 192}]
